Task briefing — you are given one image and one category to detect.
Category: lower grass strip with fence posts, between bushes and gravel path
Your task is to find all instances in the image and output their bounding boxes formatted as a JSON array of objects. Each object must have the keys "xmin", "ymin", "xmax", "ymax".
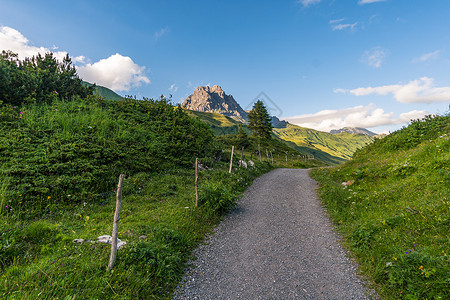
[{"xmin": 0, "ymin": 162, "xmax": 272, "ymax": 299}]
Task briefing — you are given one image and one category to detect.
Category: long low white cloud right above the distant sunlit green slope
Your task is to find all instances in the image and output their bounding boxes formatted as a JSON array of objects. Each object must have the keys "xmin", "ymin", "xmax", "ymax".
[{"xmin": 284, "ymin": 104, "xmax": 428, "ymax": 132}]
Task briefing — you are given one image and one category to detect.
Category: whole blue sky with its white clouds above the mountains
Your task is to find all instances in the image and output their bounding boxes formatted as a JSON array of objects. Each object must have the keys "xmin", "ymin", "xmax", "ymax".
[{"xmin": 0, "ymin": 0, "xmax": 450, "ymax": 132}]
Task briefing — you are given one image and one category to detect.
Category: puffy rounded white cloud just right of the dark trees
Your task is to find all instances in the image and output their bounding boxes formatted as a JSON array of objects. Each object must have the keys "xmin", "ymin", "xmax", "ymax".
[{"xmin": 77, "ymin": 53, "xmax": 150, "ymax": 91}]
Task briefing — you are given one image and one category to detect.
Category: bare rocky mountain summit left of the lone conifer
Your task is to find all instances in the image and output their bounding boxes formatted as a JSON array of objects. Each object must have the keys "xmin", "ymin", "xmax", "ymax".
[{"xmin": 181, "ymin": 85, "xmax": 247, "ymax": 122}]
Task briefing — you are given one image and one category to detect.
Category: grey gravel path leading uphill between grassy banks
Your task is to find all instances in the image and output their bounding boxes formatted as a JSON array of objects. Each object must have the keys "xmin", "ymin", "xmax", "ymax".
[{"xmin": 174, "ymin": 169, "xmax": 369, "ymax": 300}]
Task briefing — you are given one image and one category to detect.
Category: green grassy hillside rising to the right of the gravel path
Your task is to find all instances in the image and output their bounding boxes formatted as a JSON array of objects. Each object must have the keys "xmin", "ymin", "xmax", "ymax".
[{"xmin": 312, "ymin": 116, "xmax": 450, "ymax": 299}]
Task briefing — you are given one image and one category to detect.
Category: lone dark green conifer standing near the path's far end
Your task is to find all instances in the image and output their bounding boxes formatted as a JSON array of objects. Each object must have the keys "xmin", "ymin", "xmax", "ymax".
[{"xmin": 248, "ymin": 100, "xmax": 272, "ymax": 139}]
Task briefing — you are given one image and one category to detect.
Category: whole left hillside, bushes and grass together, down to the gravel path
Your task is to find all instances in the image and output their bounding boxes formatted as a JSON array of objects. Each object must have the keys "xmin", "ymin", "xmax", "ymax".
[{"xmin": 0, "ymin": 96, "xmax": 282, "ymax": 299}]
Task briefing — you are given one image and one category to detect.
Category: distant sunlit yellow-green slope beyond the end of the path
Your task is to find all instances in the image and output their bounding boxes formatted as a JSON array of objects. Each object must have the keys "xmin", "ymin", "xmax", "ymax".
[{"xmin": 273, "ymin": 124, "xmax": 373, "ymax": 164}]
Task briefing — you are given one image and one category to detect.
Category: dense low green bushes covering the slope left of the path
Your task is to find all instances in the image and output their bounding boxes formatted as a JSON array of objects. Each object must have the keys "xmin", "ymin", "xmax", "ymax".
[{"xmin": 0, "ymin": 96, "xmax": 216, "ymax": 211}]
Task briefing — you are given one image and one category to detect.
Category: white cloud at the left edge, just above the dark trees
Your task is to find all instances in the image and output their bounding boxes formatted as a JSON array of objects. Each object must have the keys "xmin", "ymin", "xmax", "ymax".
[{"xmin": 0, "ymin": 26, "xmax": 67, "ymax": 60}]
